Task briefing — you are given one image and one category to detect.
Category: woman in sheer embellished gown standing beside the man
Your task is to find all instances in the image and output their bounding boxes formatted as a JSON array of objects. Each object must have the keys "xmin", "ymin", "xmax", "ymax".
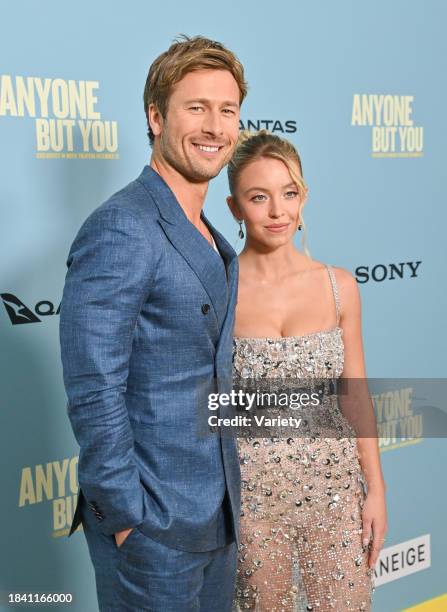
[{"xmin": 227, "ymin": 130, "xmax": 386, "ymax": 612}]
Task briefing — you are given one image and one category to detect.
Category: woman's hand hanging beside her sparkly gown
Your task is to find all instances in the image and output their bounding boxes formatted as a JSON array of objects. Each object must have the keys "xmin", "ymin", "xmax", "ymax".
[{"xmin": 362, "ymin": 488, "xmax": 388, "ymax": 569}]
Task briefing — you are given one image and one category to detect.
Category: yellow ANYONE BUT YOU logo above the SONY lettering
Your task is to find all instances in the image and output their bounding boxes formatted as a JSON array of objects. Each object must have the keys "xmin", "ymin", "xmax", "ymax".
[{"xmin": 351, "ymin": 94, "xmax": 424, "ymax": 157}]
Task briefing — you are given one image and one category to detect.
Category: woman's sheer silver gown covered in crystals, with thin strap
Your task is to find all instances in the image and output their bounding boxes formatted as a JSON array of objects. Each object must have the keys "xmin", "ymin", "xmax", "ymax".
[{"xmin": 233, "ymin": 265, "xmax": 374, "ymax": 612}]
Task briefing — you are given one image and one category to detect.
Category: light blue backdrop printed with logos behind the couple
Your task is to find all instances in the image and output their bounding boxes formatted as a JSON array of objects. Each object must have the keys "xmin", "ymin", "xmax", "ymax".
[{"xmin": 0, "ymin": 0, "xmax": 447, "ymax": 612}]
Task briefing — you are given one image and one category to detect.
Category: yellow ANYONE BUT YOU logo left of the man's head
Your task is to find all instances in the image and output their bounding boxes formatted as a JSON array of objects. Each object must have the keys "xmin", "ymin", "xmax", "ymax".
[{"xmin": 0, "ymin": 74, "xmax": 119, "ymax": 159}]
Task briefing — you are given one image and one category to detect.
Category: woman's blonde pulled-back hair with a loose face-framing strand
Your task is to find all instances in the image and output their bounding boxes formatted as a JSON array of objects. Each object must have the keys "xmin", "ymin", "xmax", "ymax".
[{"xmin": 227, "ymin": 130, "xmax": 310, "ymax": 257}]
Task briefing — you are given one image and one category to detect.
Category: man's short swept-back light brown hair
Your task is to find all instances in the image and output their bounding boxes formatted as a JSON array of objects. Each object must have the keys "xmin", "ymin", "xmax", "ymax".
[{"xmin": 143, "ymin": 34, "xmax": 248, "ymax": 146}]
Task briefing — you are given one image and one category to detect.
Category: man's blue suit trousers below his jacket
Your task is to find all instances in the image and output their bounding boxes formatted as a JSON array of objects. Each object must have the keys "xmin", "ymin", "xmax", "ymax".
[{"xmin": 81, "ymin": 494, "xmax": 237, "ymax": 612}]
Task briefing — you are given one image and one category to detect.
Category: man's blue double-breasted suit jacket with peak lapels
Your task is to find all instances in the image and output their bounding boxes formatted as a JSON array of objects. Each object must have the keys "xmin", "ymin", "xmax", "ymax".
[{"xmin": 60, "ymin": 165, "xmax": 240, "ymax": 552}]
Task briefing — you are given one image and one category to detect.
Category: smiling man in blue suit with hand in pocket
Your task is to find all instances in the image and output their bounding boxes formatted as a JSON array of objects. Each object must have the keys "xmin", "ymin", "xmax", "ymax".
[{"xmin": 60, "ymin": 36, "xmax": 247, "ymax": 612}]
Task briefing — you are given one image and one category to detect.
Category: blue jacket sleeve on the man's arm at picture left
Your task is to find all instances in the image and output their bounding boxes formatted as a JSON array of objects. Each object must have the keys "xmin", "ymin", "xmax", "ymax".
[{"xmin": 60, "ymin": 208, "xmax": 153, "ymax": 534}]
